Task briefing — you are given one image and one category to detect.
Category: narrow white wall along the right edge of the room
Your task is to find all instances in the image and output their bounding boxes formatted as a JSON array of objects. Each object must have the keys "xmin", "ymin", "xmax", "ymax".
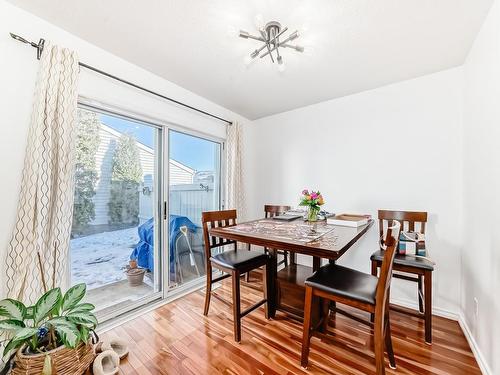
[{"xmin": 462, "ymin": 1, "xmax": 500, "ymax": 374}]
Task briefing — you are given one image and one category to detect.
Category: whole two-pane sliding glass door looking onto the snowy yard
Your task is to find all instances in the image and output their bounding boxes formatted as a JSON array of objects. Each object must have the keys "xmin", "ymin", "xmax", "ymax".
[{"xmin": 70, "ymin": 105, "xmax": 222, "ymax": 322}]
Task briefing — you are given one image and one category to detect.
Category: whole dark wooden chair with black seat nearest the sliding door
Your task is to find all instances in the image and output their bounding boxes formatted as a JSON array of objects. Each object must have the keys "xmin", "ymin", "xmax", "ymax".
[{"xmin": 201, "ymin": 210, "xmax": 270, "ymax": 342}]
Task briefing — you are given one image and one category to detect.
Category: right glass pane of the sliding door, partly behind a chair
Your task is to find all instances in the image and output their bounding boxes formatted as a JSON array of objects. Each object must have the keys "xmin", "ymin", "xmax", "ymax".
[{"xmin": 168, "ymin": 130, "xmax": 221, "ymax": 289}]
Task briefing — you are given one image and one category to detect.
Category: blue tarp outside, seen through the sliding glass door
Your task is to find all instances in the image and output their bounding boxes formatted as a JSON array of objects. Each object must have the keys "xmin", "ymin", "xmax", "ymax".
[{"xmin": 130, "ymin": 215, "xmax": 198, "ymax": 274}]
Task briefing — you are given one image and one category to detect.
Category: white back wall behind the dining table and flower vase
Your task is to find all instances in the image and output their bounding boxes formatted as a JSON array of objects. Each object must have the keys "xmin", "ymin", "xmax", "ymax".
[{"xmin": 246, "ymin": 68, "xmax": 462, "ymax": 314}]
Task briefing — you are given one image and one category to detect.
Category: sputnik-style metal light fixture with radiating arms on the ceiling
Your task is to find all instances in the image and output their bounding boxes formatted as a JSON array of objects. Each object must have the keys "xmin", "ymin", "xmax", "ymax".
[{"xmin": 239, "ymin": 16, "xmax": 304, "ymax": 72}]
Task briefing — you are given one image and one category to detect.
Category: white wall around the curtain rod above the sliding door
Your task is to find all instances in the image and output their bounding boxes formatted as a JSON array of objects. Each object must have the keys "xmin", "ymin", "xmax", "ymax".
[{"xmin": 0, "ymin": 0, "xmax": 248, "ymax": 296}]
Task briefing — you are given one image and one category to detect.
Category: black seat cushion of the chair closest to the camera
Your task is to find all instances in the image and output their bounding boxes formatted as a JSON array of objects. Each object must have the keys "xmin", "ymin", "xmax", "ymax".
[{"xmin": 305, "ymin": 264, "xmax": 378, "ymax": 305}]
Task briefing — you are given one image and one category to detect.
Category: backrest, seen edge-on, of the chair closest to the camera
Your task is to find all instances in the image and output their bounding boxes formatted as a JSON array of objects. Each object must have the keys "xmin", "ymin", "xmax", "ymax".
[{"xmin": 375, "ymin": 221, "xmax": 401, "ymax": 308}]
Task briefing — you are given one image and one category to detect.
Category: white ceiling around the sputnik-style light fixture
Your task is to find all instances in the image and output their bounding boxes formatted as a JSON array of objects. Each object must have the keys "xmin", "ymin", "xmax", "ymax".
[{"xmin": 10, "ymin": 0, "xmax": 492, "ymax": 119}]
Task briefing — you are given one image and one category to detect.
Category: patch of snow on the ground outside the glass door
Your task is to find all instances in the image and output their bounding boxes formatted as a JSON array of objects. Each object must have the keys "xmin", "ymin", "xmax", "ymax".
[{"xmin": 70, "ymin": 227, "xmax": 139, "ymax": 289}]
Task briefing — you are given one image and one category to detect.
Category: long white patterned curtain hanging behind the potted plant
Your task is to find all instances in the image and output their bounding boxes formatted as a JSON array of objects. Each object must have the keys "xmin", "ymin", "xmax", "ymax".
[{"xmin": 6, "ymin": 42, "xmax": 79, "ymax": 303}]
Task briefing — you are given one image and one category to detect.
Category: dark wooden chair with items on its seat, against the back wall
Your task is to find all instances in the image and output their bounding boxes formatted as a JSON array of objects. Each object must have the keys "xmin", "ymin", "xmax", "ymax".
[{"xmin": 370, "ymin": 210, "xmax": 434, "ymax": 344}]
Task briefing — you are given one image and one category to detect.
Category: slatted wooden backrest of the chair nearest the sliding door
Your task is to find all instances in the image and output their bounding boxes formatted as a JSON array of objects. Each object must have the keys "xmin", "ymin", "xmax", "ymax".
[{"xmin": 201, "ymin": 210, "xmax": 237, "ymax": 265}]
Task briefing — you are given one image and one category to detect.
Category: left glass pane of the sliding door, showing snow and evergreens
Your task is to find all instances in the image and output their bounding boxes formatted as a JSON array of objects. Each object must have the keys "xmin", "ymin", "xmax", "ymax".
[{"xmin": 70, "ymin": 108, "xmax": 162, "ymax": 317}]
